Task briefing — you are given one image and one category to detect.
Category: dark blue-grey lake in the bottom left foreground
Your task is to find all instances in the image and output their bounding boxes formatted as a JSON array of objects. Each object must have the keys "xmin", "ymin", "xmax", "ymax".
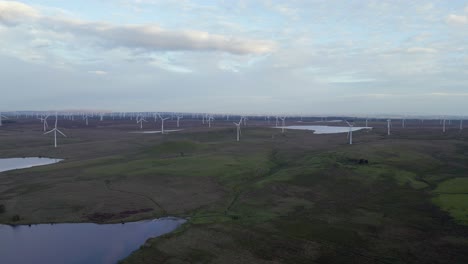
[{"xmin": 0, "ymin": 217, "xmax": 186, "ymax": 264}]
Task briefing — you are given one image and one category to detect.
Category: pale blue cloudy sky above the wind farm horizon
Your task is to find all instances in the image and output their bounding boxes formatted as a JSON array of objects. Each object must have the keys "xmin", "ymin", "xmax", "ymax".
[{"xmin": 0, "ymin": 0, "xmax": 468, "ymax": 115}]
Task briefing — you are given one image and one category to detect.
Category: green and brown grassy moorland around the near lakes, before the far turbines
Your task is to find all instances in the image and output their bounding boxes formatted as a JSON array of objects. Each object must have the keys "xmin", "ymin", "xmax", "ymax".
[{"xmin": 0, "ymin": 120, "xmax": 468, "ymax": 263}]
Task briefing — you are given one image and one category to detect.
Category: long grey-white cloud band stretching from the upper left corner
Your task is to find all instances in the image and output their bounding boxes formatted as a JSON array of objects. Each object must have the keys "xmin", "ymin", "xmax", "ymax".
[{"xmin": 0, "ymin": 1, "xmax": 275, "ymax": 55}]
